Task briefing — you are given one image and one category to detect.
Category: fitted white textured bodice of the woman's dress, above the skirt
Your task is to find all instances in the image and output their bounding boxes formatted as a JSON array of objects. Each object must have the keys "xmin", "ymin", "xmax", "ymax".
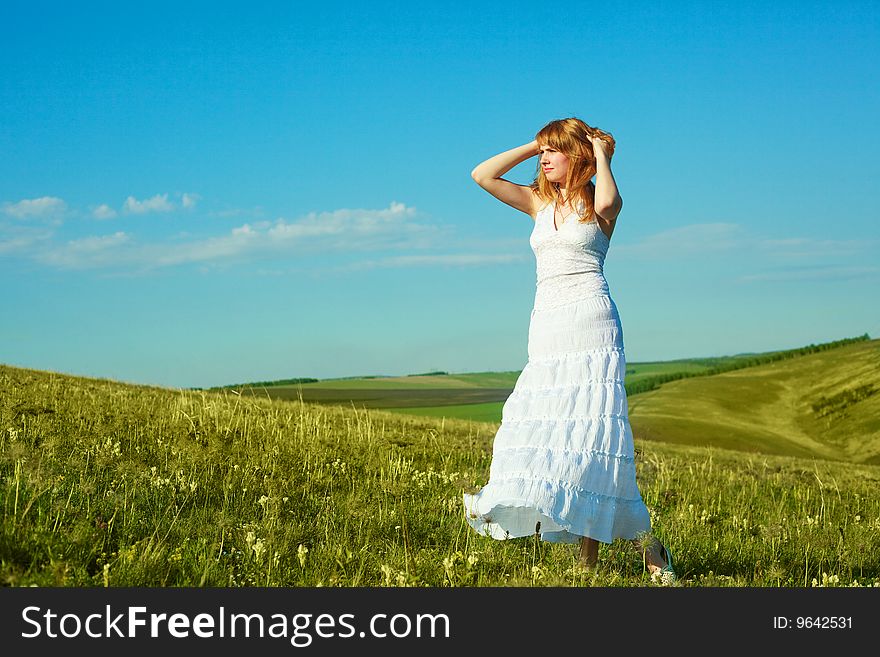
[{"xmin": 529, "ymin": 203, "xmax": 611, "ymax": 309}]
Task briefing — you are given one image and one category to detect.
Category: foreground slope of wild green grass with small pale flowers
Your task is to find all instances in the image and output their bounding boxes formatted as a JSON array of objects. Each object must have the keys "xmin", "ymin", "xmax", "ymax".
[{"xmin": 0, "ymin": 366, "xmax": 880, "ymax": 587}]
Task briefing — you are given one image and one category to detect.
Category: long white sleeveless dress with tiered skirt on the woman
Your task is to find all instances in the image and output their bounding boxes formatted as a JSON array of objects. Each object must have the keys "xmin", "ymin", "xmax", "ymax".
[{"xmin": 464, "ymin": 203, "xmax": 651, "ymax": 543}]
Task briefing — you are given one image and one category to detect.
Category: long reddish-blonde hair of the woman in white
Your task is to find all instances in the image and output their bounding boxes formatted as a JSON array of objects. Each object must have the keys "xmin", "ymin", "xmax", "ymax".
[{"xmin": 531, "ymin": 117, "xmax": 614, "ymax": 223}]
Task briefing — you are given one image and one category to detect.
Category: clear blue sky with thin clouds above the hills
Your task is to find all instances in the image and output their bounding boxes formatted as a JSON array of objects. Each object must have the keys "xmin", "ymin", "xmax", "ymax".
[{"xmin": 0, "ymin": 1, "xmax": 880, "ymax": 387}]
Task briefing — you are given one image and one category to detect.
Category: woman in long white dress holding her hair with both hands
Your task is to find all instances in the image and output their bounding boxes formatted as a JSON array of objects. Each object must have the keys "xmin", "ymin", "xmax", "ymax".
[{"xmin": 464, "ymin": 118, "xmax": 676, "ymax": 584}]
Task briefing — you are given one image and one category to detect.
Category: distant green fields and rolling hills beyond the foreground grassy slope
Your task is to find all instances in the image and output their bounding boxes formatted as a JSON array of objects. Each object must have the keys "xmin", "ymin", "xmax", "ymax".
[{"xmin": 213, "ymin": 336, "xmax": 880, "ymax": 464}]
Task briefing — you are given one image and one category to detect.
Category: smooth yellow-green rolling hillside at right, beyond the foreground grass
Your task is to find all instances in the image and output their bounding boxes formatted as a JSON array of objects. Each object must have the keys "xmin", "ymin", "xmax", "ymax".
[{"xmin": 629, "ymin": 339, "xmax": 880, "ymax": 463}]
